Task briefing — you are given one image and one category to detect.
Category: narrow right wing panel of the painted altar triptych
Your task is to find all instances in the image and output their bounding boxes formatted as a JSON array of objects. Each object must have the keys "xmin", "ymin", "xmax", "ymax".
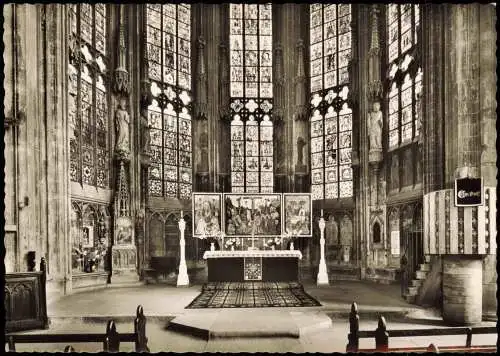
[{"xmin": 283, "ymin": 193, "xmax": 312, "ymax": 236}]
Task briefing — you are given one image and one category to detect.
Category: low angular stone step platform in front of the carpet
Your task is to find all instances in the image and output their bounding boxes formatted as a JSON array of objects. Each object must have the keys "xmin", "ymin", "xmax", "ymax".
[{"xmin": 168, "ymin": 308, "xmax": 332, "ymax": 340}]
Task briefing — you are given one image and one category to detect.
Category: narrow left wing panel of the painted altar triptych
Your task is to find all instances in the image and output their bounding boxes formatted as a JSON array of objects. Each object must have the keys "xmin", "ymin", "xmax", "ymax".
[{"xmin": 192, "ymin": 193, "xmax": 222, "ymax": 237}]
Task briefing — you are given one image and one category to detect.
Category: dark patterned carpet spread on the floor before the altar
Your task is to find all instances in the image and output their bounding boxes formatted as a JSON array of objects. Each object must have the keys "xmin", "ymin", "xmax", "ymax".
[{"xmin": 186, "ymin": 282, "xmax": 321, "ymax": 309}]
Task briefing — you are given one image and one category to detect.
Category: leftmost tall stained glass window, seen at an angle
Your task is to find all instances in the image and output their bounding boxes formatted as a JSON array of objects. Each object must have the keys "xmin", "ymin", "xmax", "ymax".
[{"xmin": 68, "ymin": 4, "xmax": 110, "ymax": 188}]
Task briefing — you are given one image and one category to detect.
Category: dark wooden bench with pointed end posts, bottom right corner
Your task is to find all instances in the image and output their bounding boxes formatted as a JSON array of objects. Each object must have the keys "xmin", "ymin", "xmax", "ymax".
[{"xmin": 346, "ymin": 303, "xmax": 497, "ymax": 352}]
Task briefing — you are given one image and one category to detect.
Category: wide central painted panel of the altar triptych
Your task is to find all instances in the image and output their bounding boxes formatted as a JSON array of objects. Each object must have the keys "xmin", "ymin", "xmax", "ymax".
[{"xmin": 224, "ymin": 194, "xmax": 282, "ymax": 237}]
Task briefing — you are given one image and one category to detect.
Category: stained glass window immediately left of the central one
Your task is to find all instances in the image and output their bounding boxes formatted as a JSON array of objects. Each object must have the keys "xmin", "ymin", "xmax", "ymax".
[{"xmin": 146, "ymin": 4, "xmax": 192, "ymax": 199}]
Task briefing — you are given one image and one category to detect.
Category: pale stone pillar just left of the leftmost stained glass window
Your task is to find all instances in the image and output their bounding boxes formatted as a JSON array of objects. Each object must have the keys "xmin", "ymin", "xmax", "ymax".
[{"xmin": 43, "ymin": 4, "xmax": 71, "ymax": 294}]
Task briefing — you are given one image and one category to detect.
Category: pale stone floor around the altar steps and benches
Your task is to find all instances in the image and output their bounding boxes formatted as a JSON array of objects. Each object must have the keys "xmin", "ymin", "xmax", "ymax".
[{"xmin": 7, "ymin": 281, "xmax": 497, "ymax": 352}]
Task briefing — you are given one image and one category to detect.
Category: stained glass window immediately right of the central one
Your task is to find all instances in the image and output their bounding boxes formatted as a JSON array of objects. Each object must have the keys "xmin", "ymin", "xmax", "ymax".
[{"xmin": 310, "ymin": 4, "xmax": 353, "ymax": 200}]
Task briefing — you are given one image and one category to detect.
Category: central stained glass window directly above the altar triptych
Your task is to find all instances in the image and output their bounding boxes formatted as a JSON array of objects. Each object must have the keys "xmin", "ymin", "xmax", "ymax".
[{"xmin": 230, "ymin": 4, "xmax": 274, "ymax": 193}]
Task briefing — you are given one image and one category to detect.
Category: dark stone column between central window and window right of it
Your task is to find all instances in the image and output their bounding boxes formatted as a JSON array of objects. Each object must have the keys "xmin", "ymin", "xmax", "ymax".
[{"xmin": 273, "ymin": 3, "xmax": 309, "ymax": 192}]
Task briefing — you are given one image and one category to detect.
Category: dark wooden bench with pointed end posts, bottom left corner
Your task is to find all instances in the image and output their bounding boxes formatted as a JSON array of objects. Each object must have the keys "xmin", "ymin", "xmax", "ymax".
[{"xmin": 5, "ymin": 305, "xmax": 149, "ymax": 352}]
